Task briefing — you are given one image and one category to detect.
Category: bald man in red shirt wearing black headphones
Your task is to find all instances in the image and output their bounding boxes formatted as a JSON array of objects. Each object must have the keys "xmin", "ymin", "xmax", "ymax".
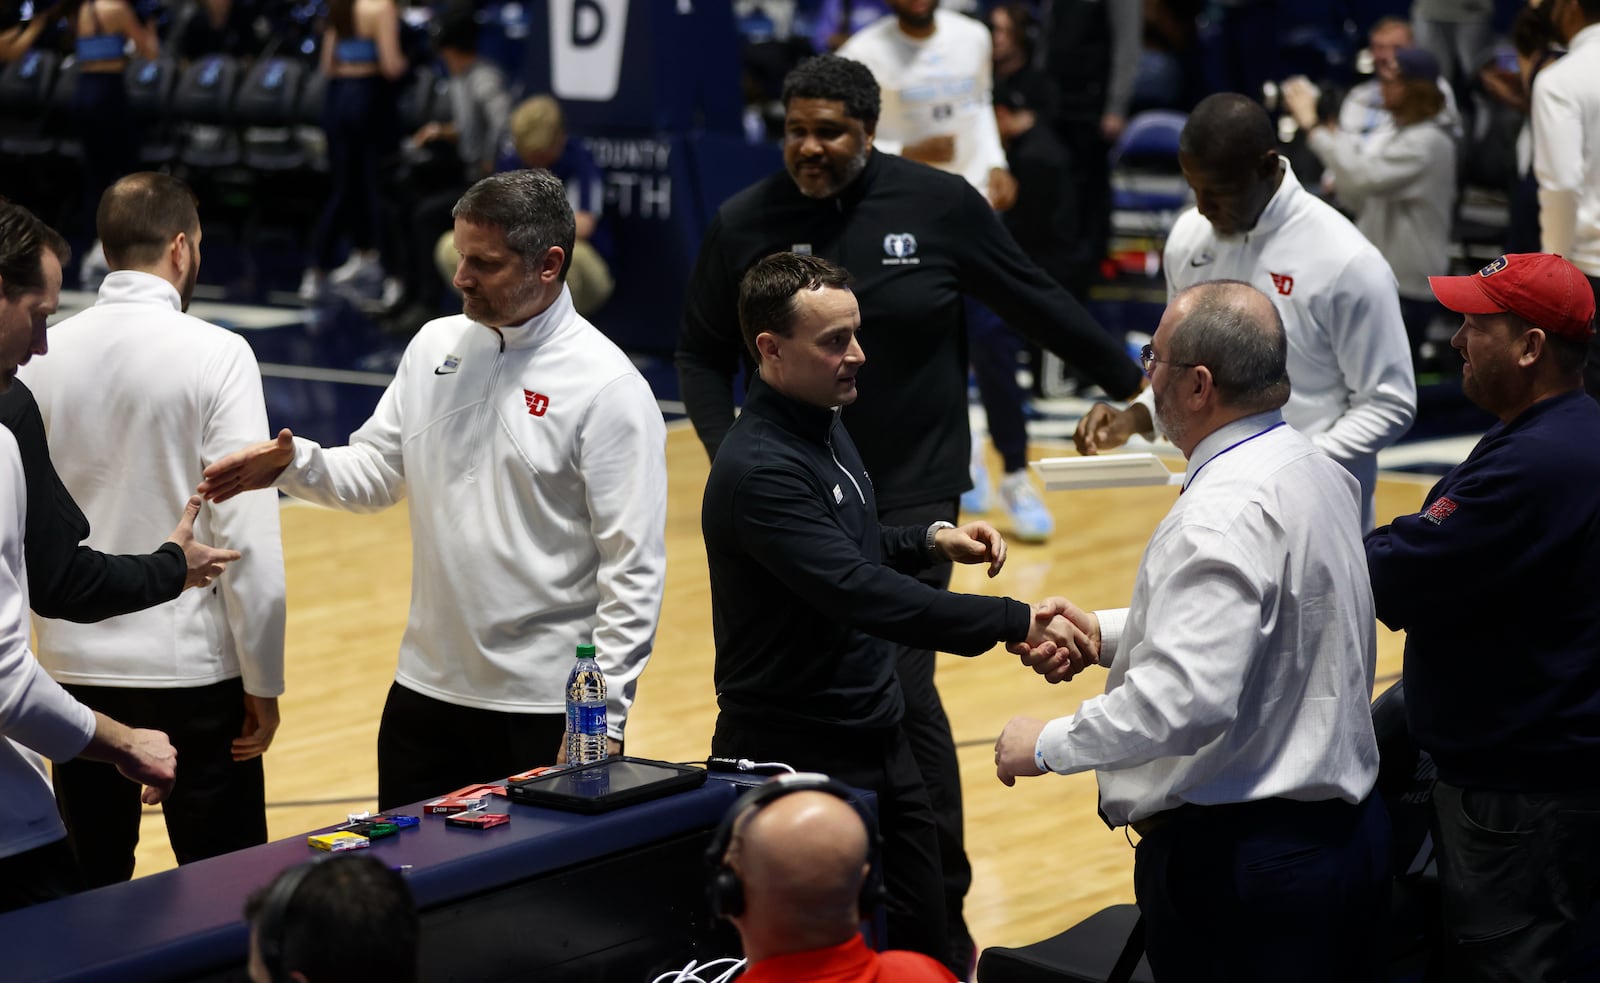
[{"xmin": 709, "ymin": 773, "xmax": 955, "ymax": 983}]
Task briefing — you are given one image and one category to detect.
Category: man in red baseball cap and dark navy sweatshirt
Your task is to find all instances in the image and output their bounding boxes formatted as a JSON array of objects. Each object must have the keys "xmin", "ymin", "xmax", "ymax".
[{"xmin": 1366, "ymin": 253, "xmax": 1600, "ymax": 981}]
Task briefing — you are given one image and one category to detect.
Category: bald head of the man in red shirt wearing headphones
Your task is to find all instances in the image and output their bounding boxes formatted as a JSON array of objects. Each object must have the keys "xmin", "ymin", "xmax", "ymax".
[{"xmin": 726, "ymin": 791, "xmax": 869, "ymax": 957}]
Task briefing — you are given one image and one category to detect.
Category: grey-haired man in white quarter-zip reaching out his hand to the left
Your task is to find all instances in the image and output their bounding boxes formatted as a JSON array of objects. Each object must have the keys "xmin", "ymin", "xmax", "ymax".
[{"xmin": 200, "ymin": 170, "xmax": 667, "ymax": 808}]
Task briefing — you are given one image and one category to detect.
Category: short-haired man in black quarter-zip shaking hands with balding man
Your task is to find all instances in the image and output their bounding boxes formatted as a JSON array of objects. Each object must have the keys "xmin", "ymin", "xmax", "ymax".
[{"xmin": 701, "ymin": 253, "xmax": 1068, "ymax": 975}]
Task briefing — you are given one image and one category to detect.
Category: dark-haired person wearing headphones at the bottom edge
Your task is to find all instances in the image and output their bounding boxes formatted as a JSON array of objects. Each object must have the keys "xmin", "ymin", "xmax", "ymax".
[{"xmin": 245, "ymin": 853, "xmax": 421, "ymax": 983}]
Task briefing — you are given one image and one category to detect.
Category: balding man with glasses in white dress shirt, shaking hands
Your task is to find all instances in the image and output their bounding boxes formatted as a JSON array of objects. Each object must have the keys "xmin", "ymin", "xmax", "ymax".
[{"xmin": 995, "ymin": 280, "xmax": 1389, "ymax": 983}]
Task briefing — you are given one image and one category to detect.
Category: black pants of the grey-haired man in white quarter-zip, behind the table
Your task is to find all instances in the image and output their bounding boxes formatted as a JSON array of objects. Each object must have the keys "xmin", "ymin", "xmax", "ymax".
[{"xmin": 378, "ymin": 682, "xmax": 566, "ymax": 810}]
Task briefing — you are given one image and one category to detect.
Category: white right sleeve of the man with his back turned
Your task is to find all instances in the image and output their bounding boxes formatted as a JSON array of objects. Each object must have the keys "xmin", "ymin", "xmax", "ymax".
[{"xmin": 200, "ymin": 336, "xmax": 285, "ymax": 696}]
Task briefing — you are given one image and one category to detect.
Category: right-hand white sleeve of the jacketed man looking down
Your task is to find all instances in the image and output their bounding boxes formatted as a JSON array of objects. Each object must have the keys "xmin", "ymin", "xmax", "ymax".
[{"xmin": 1310, "ymin": 248, "xmax": 1416, "ymax": 463}]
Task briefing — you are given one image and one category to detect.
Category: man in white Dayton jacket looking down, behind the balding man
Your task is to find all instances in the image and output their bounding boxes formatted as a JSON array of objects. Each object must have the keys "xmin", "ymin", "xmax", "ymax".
[{"xmin": 1074, "ymin": 93, "xmax": 1416, "ymax": 528}]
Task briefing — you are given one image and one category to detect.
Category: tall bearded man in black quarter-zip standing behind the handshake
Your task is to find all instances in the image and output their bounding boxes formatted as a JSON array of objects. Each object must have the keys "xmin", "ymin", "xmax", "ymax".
[{"xmin": 677, "ymin": 56, "xmax": 1142, "ymax": 973}]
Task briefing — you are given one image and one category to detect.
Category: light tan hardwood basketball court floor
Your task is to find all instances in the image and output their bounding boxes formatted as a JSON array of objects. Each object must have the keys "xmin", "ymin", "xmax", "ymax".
[{"xmin": 121, "ymin": 423, "xmax": 1434, "ymax": 946}]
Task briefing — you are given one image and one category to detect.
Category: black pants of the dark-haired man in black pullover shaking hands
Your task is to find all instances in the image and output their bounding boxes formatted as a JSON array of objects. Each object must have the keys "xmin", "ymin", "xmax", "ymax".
[{"xmin": 710, "ymin": 712, "xmax": 947, "ymax": 977}]
